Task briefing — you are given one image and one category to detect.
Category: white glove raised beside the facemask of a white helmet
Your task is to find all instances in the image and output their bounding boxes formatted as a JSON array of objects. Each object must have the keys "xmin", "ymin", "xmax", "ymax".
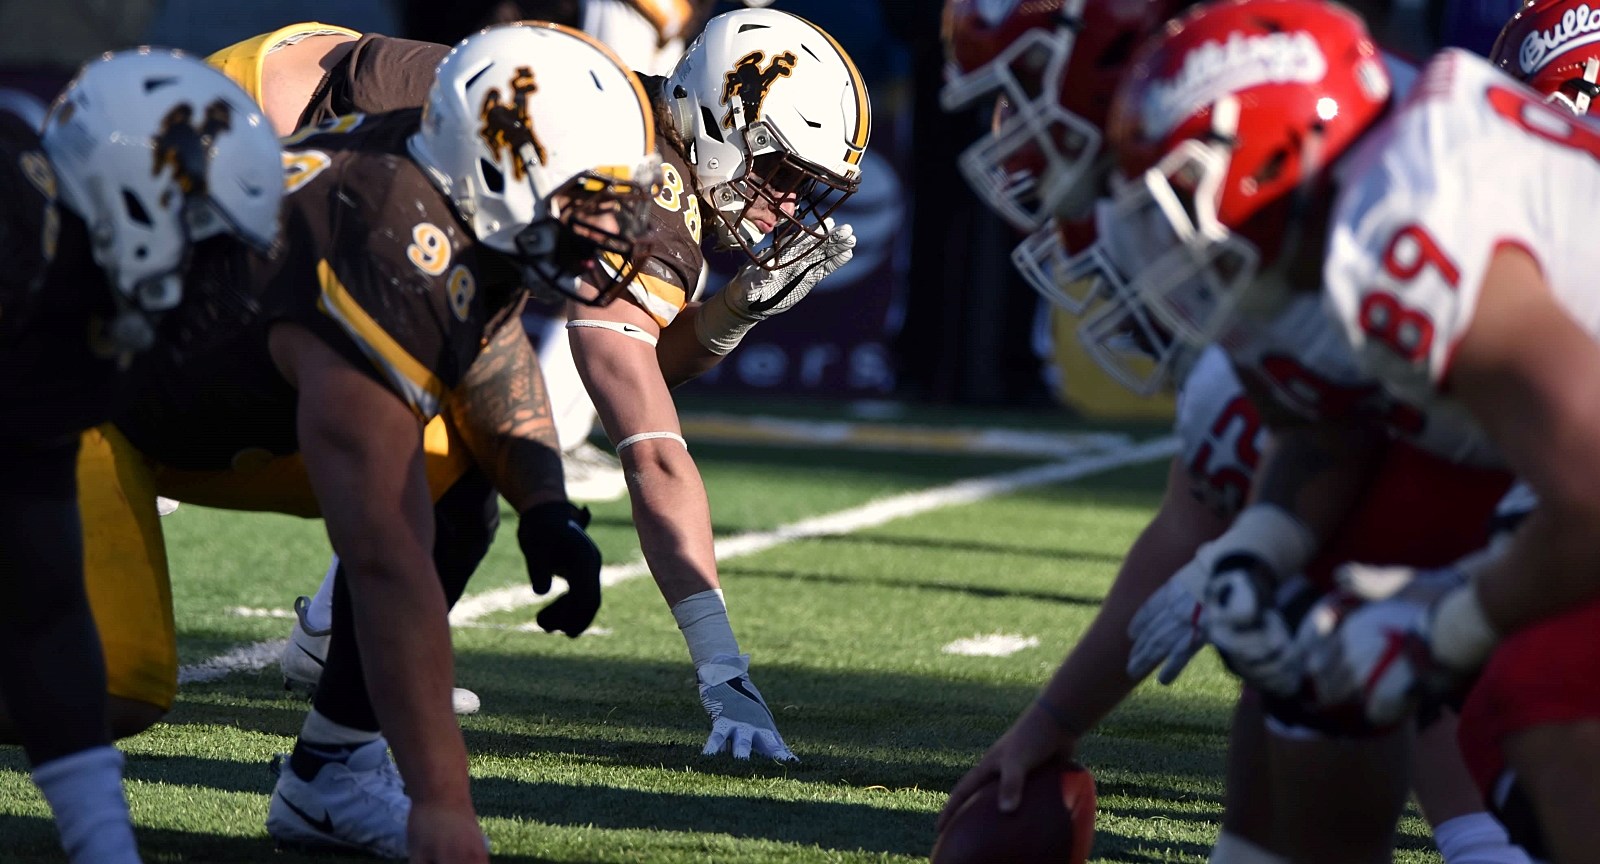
[{"xmin": 694, "ymin": 218, "xmax": 856, "ymax": 354}]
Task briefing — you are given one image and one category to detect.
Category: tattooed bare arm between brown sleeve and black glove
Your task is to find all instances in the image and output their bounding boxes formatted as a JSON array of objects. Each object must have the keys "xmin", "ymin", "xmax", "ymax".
[{"xmin": 448, "ymin": 317, "xmax": 566, "ymax": 512}]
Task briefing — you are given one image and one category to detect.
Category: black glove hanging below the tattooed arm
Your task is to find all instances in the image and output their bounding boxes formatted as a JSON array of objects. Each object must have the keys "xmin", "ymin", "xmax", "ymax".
[{"xmin": 517, "ymin": 501, "xmax": 600, "ymax": 638}]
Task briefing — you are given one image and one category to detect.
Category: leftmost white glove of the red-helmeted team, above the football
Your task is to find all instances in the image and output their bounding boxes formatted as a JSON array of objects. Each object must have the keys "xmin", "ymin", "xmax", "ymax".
[{"xmin": 1128, "ymin": 542, "xmax": 1214, "ymax": 683}]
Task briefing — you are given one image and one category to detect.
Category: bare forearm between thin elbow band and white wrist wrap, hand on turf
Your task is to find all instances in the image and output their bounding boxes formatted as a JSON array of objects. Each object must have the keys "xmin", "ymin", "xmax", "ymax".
[{"xmin": 622, "ymin": 438, "xmax": 718, "ymax": 606}]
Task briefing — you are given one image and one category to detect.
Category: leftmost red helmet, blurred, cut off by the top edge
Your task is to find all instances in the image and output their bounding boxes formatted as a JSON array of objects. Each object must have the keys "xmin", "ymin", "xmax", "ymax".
[{"xmin": 941, "ymin": 0, "xmax": 1179, "ymax": 230}]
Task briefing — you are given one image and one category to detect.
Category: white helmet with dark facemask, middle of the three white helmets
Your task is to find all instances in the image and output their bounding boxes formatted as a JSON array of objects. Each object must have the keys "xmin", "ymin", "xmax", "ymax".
[{"xmin": 410, "ymin": 21, "xmax": 661, "ymax": 306}]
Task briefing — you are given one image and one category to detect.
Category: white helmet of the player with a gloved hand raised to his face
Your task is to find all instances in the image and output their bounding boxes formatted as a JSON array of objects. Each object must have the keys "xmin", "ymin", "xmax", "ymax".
[{"xmin": 662, "ymin": 10, "xmax": 872, "ymax": 267}]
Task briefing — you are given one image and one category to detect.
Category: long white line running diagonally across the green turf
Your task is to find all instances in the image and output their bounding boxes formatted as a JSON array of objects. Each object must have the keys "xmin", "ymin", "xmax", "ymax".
[{"xmin": 178, "ymin": 435, "xmax": 1178, "ymax": 683}]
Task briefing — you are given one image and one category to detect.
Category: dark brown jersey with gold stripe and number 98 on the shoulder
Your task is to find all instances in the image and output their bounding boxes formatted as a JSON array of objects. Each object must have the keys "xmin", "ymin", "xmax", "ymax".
[{"xmin": 118, "ymin": 109, "xmax": 522, "ymax": 470}]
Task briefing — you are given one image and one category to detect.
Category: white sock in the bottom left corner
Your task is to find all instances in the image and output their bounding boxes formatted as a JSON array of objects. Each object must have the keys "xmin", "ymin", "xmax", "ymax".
[{"xmin": 34, "ymin": 746, "xmax": 139, "ymax": 864}]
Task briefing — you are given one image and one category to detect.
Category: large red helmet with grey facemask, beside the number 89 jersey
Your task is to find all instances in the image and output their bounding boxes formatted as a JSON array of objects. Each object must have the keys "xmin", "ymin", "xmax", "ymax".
[{"xmin": 1078, "ymin": 0, "xmax": 1390, "ymax": 392}]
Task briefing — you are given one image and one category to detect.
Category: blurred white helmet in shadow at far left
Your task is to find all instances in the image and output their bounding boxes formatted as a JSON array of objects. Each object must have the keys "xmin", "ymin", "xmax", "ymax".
[{"xmin": 40, "ymin": 48, "xmax": 283, "ymax": 350}]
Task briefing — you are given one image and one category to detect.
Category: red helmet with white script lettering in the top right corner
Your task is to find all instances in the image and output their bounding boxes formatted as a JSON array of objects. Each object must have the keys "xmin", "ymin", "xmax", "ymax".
[{"xmin": 1490, "ymin": 0, "xmax": 1600, "ymax": 114}]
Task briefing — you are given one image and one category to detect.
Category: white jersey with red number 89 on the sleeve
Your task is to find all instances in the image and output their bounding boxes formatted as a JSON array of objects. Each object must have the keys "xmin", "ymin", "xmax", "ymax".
[{"xmin": 1323, "ymin": 50, "xmax": 1600, "ymax": 464}]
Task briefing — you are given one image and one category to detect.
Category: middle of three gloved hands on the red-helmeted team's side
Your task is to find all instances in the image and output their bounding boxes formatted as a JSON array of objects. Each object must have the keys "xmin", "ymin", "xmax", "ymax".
[{"xmin": 1202, "ymin": 554, "xmax": 1302, "ymax": 696}]
